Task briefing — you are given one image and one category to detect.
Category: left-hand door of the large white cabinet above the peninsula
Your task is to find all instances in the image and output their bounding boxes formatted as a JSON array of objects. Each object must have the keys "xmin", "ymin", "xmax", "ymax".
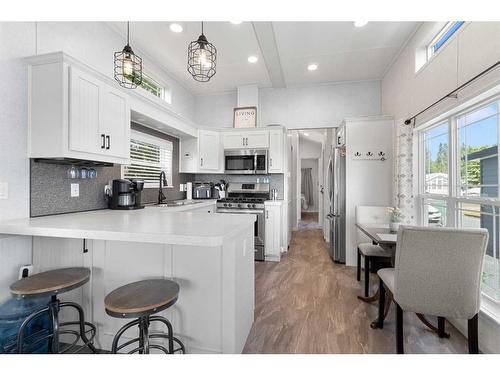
[{"xmin": 69, "ymin": 67, "xmax": 104, "ymax": 153}]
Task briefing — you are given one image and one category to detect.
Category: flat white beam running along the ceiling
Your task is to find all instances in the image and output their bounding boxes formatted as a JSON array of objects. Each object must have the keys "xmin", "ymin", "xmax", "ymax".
[{"xmin": 252, "ymin": 22, "xmax": 286, "ymax": 88}]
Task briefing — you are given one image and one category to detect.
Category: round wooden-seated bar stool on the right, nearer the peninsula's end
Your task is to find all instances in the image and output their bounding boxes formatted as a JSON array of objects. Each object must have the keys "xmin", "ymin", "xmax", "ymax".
[{"xmin": 104, "ymin": 279, "xmax": 186, "ymax": 354}]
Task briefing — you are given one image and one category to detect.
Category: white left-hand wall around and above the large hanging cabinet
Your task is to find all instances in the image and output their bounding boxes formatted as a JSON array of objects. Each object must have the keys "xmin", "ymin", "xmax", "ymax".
[{"xmin": 0, "ymin": 22, "xmax": 198, "ymax": 301}]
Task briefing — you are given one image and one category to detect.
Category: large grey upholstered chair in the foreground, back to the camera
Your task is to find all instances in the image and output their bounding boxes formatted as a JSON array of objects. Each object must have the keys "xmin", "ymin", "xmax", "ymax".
[{"xmin": 378, "ymin": 226, "xmax": 488, "ymax": 353}]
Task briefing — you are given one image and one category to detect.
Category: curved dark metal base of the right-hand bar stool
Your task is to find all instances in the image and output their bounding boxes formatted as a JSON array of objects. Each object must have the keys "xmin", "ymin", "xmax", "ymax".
[{"xmin": 111, "ymin": 315, "xmax": 186, "ymax": 354}]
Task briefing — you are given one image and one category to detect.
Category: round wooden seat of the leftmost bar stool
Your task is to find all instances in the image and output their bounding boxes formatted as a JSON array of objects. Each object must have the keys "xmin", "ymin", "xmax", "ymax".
[{"xmin": 10, "ymin": 267, "xmax": 90, "ymax": 296}]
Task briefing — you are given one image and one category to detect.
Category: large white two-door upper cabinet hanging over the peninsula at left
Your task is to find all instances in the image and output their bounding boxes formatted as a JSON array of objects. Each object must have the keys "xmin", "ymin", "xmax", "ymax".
[{"xmin": 27, "ymin": 53, "xmax": 130, "ymax": 164}]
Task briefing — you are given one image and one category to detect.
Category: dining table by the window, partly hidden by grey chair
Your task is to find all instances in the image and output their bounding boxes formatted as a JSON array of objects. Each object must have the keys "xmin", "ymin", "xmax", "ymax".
[{"xmin": 356, "ymin": 223, "xmax": 450, "ymax": 338}]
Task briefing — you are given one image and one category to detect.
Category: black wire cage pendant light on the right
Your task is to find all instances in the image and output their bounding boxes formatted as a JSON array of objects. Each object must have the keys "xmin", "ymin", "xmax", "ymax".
[{"xmin": 188, "ymin": 22, "xmax": 217, "ymax": 82}]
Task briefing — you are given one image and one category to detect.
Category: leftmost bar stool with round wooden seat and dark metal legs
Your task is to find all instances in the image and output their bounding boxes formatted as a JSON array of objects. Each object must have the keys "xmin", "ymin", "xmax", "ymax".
[{"xmin": 10, "ymin": 267, "xmax": 97, "ymax": 354}]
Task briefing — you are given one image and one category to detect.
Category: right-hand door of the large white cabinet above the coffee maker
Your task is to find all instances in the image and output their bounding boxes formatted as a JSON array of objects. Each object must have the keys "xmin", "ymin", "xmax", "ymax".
[{"xmin": 100, "ymin": 84, "xmax": 130, "ymax": 159}]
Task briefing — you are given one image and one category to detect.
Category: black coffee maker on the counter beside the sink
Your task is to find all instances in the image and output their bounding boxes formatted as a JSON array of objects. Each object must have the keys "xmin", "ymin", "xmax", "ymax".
[{"xmin": 107, "ymin": 180, "xmax": 144, "ymax": 210}]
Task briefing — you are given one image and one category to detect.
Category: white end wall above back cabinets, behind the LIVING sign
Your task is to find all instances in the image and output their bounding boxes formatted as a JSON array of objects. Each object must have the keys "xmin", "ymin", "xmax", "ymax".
[{"xmin": 195, "ymin": 81, "xmax": 380, "ymax": 129}]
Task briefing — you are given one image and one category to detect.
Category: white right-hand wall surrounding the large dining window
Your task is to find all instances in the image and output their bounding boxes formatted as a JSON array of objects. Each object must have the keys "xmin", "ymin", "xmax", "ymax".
[{"xmin": 382, "ymin": 22, "xmax": 500, "ymax": 353}]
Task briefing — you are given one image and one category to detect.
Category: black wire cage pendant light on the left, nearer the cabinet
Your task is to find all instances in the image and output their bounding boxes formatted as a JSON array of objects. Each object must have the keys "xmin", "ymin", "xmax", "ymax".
[{"xmin": 115, "ymin": 21, "xmax": 142, "ymax": 89}]
